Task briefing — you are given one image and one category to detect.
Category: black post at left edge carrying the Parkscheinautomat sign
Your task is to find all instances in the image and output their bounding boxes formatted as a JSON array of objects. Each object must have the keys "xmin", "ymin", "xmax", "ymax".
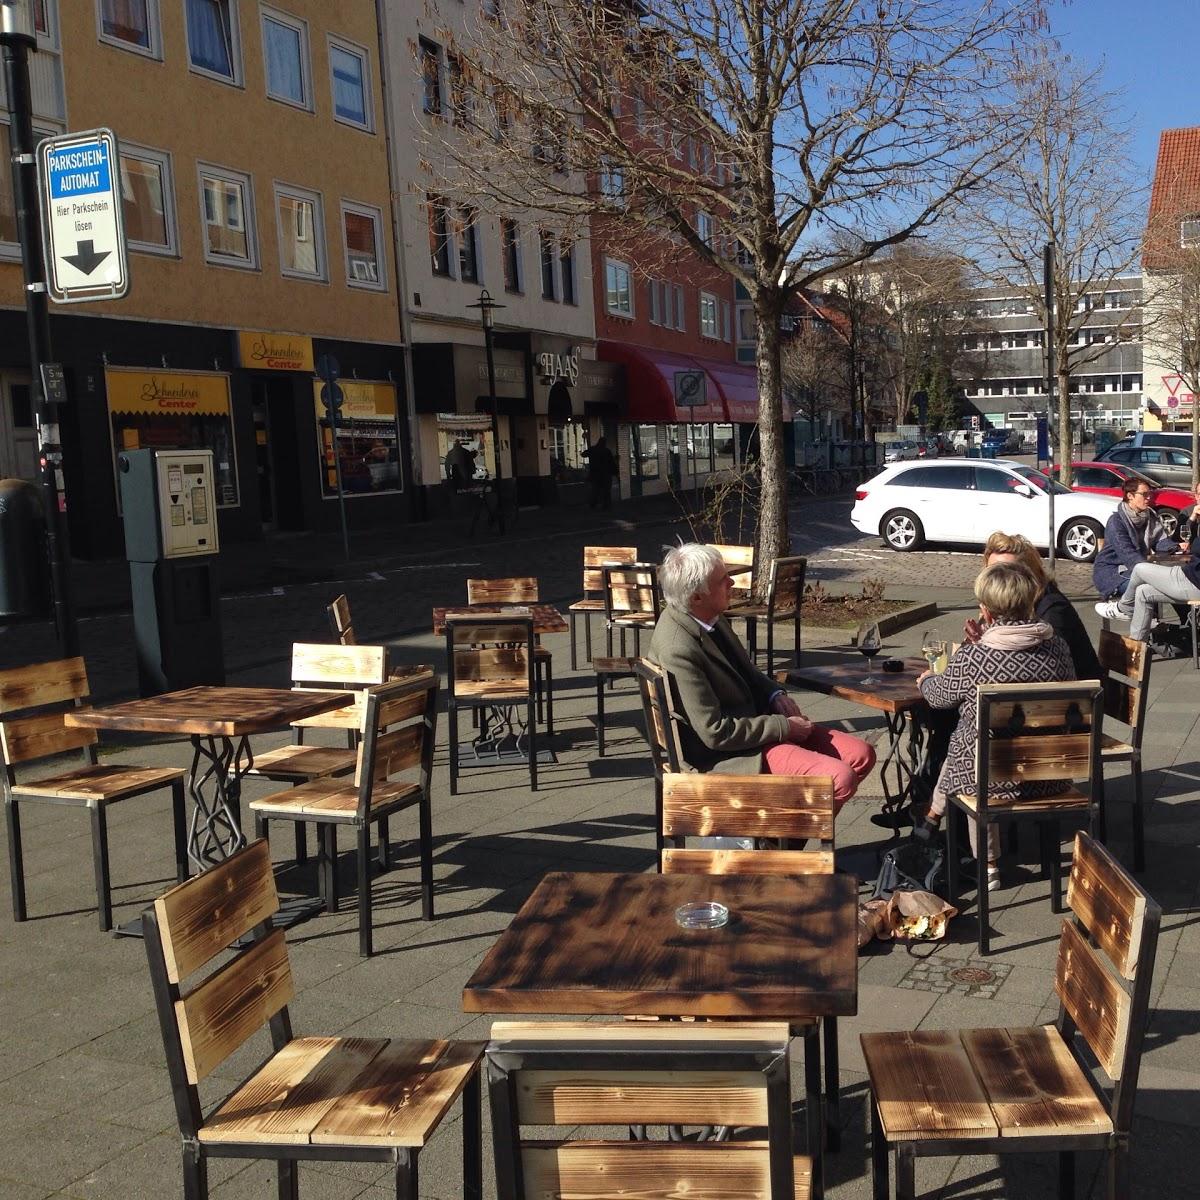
[{"xmin": 0, "ymin": 0, "xmax": 79, "ymax": 658}]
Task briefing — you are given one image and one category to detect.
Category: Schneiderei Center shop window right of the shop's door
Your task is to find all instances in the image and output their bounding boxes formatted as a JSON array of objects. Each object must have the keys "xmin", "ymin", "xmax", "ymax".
[{"xmin": 313, "ymin": 379, "xmax": 402, "ymax": 499}]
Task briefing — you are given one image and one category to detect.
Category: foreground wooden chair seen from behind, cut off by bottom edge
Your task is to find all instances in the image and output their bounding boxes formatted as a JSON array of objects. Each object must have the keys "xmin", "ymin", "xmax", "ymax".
[{"xmin": 487, "ymin": 1021, "xmax": 811, "ymax": 1200}]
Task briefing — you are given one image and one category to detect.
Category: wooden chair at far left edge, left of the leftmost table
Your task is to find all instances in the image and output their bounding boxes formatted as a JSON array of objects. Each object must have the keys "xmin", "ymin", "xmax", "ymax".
[{"xmin": 0, "ymin": 659, "xmax": 187, "ymax": 930}]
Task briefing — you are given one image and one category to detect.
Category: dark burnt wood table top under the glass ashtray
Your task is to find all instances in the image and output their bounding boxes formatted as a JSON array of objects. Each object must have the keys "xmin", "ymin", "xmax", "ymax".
[{"xmin": 462, "ymin": 871, "xmax": 858, "ymax": 1020}]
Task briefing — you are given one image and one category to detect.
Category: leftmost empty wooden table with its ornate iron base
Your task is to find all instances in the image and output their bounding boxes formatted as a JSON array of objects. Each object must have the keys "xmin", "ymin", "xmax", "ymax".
[{"xmin": 66, "ymin": 688, "xmax": 354, "ymax": 870}]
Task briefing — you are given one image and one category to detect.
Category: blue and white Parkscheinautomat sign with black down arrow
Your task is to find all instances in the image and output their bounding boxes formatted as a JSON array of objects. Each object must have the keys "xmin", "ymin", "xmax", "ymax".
[{"xmin": 37, "ymin": 130, "xmax": 130, "ymax": 304}]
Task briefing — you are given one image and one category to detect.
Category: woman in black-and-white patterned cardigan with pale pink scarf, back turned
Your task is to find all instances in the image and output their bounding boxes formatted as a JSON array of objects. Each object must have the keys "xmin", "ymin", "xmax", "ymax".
[{"xmin": 913, "ymin": 563, "xmax": 1076, "ymax": 892}]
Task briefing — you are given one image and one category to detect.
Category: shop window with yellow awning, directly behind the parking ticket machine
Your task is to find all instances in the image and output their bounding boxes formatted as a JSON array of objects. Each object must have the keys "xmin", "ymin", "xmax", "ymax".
[{"xmin": 104, "ymin": 367, "xmax": 240, "ymax": 509}]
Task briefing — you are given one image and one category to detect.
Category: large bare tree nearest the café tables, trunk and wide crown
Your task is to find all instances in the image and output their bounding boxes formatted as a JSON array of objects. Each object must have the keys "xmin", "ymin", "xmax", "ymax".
[{"xmin": 434, "ymin": 0, "xmax": 1043, "ymax": 576}]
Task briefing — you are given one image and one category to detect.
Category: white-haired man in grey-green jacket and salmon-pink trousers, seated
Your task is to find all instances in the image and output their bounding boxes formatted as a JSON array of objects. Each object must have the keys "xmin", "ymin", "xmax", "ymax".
[{"xmin": 649, "ymin": 542, "xmax": 875, "ymax": 808}]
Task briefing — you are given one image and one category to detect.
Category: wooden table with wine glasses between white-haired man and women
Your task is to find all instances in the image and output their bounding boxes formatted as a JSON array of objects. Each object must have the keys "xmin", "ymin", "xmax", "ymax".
[{"xmin": 775, "ymin": 659, "xmax": 929, "ymax": 834}]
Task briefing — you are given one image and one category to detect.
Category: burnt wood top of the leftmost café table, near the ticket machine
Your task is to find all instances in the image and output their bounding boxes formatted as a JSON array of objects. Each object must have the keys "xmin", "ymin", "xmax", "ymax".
[{"xmin": 66, "ymin": 688, "xmax": 354, "ymax": 738}]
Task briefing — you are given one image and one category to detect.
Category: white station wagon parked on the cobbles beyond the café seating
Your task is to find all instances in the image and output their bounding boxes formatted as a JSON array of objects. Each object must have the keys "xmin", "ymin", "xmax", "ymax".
[{"xmin": 850, "ymin": 458, "xmax": 1118, "ymax": 563}]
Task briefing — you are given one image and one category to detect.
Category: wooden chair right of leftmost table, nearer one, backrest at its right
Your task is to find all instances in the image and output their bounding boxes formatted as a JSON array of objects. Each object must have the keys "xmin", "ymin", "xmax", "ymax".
[{"xmin": 250, "ymin": 674, "xmax": 438, "ymax": 958}]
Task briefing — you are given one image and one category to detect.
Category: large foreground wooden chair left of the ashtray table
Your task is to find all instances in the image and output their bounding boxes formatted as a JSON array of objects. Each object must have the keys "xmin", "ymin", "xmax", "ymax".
[{"xmin": 143, "ymin": 841, "xmax": 484, "ymax": 1200}]
